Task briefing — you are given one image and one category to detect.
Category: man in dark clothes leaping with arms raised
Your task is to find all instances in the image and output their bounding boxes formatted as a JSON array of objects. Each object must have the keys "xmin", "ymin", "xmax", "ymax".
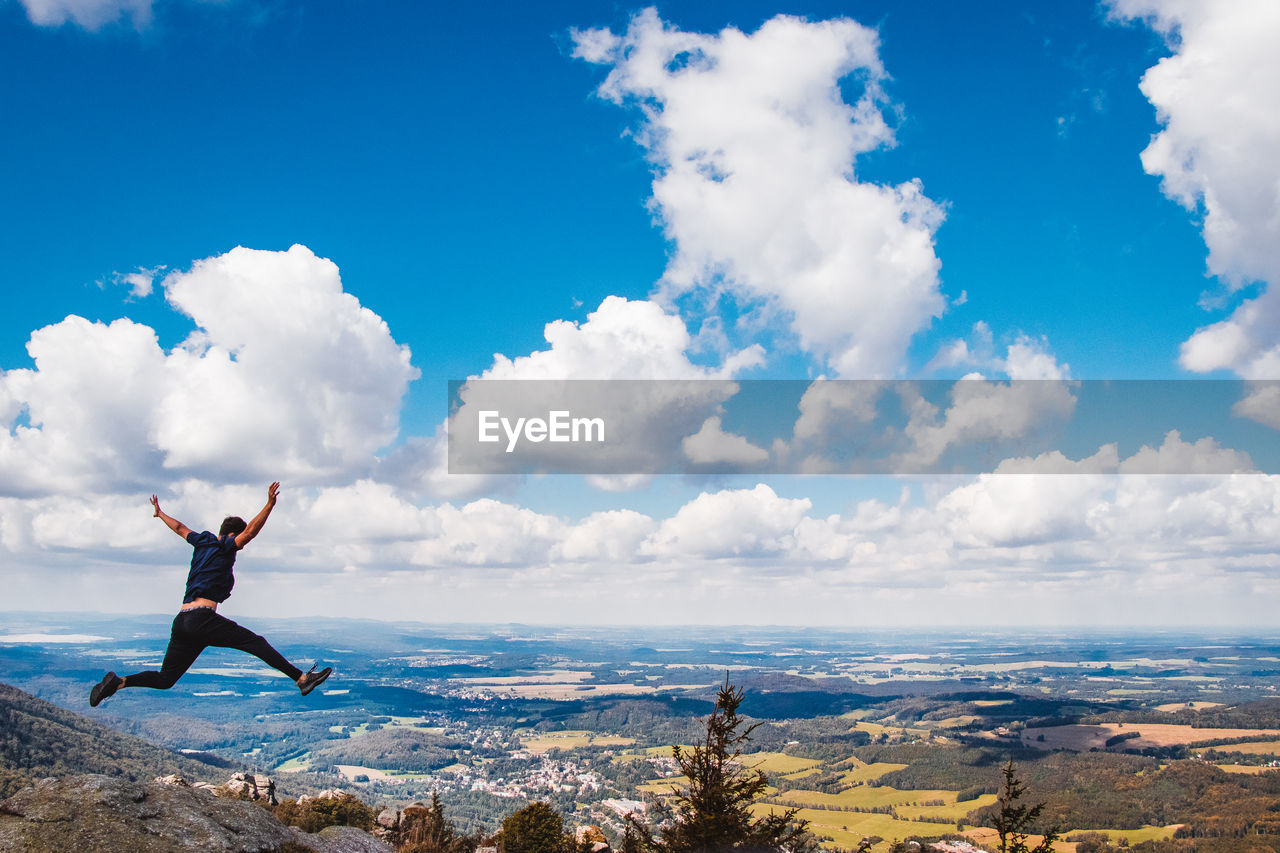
[{"xmin": 88, "ymin": 483, "xmax": 333, "ymax": 707}]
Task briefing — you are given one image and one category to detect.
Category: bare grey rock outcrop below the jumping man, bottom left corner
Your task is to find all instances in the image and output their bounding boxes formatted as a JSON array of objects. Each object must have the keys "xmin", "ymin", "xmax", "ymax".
[{"xmin": 0, "ymin": 775, "xmax": 392, "ymax": 853}]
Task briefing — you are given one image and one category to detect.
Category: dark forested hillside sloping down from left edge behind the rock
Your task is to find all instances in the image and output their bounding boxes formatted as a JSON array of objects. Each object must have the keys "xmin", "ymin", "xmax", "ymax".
[{"xmin": 0, "ymin": 684, "xmax": 227, "ymax": 799}]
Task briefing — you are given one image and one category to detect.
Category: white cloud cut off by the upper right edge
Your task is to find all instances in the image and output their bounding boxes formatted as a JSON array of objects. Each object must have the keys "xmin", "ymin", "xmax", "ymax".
[{"xmin": 1111, "ymin": 0, "xmax": 1280, "ymax": 378}]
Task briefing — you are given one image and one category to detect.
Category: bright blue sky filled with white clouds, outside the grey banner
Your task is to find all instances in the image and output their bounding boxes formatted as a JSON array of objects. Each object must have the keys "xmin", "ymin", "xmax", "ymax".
[{"xmin": 0, "ymin": 0, "xmax": 1280, "ymax": 624}]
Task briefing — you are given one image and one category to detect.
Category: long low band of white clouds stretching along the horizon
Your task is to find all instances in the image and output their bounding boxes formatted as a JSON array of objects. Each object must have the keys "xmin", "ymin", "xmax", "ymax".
[{"xmin": 0, "ymin": 461, "xmax": 1280, "ymax": 624}]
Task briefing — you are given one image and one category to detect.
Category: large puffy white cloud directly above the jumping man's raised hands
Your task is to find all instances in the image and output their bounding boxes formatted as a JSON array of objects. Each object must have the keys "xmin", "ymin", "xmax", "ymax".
[{"xmin": 0, "ymin": 246, "xmax": 417, "ymax": 494}]
